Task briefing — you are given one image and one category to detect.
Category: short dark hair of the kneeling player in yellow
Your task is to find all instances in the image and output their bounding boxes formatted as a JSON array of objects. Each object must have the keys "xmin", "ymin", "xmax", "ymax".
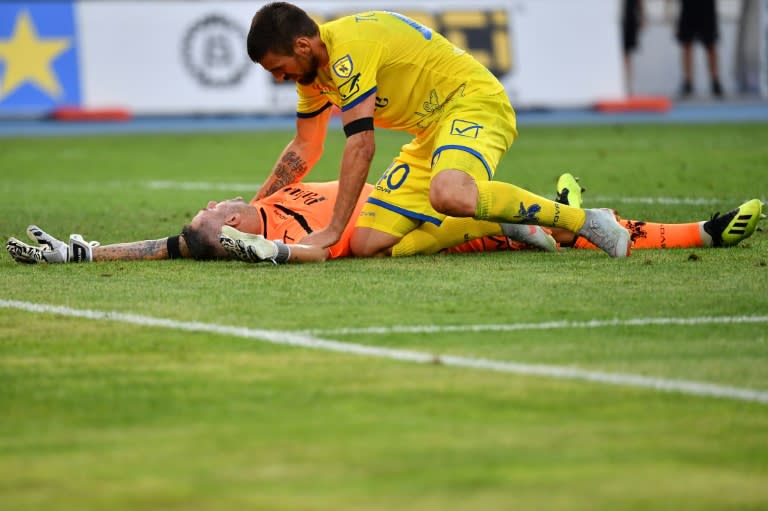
[{"xmin": 248, "ymin": 2, "xmax": 320, "ymax": 62}]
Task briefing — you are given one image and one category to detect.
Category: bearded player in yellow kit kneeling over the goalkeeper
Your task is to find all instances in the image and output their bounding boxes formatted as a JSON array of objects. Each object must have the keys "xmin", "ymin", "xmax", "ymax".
[{"xmin": 248, "ymin": 2, "xmax": 631, "ymax": 257}]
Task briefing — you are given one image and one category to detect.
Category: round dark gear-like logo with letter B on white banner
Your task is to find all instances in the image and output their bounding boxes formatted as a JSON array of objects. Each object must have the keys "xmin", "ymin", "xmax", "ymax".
[{"xmin": 181, "ymin": 14, "xmax": 251, "ymax": 87}]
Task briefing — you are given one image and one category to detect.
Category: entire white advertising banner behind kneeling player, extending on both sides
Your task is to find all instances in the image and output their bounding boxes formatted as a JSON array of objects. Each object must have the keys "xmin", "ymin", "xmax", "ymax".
[{"xmin": 76, "ymin": 0, "xmax": 624, "ymax": 114}]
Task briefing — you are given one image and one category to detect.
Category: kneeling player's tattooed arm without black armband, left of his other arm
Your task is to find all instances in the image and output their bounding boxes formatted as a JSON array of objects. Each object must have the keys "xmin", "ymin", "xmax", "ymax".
[{"xmin": 254, "ymin": 108, "xmax": 331, "ymax": 200}]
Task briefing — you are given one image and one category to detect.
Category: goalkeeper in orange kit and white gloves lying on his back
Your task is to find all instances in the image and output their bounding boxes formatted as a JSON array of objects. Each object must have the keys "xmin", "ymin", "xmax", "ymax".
[{"xmin": 6, "ymin": 174, "xmax": 763, "ymax": 263}]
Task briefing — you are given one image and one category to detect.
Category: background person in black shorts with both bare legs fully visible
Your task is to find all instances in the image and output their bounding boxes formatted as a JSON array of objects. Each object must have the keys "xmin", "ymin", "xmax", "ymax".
[{"xmin": 677, "ymin": 0, "xmax": 723, "ymax": 98}]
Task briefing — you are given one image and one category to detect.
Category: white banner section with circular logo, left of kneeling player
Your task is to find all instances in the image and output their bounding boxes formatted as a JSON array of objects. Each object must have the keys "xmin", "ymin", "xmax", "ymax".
[{"xmin": 77, "ymin": 1, "xmax": 273, "ymax": 114}]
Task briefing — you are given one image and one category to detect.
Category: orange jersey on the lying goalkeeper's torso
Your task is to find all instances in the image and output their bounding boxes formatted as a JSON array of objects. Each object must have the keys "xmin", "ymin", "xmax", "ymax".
[{"xmin": 251, "ymin": 181, "xmax": 373, "ymax": 259}]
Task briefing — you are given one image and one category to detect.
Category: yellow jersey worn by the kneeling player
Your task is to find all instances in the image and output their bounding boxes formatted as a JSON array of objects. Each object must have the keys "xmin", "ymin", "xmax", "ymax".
[{"xmin": 297, "ymin": 11, "xmax": 504, "ymax": 136}]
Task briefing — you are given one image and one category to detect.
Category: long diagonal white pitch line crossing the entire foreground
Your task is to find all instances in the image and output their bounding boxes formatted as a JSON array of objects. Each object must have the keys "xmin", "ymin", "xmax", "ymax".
[{"xmin": 0, "ymin": 299, "xmax": 768, "ymax": 404}]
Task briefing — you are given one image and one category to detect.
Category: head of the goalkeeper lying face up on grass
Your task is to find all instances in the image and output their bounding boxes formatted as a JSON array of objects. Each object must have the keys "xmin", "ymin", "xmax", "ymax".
[{"xmin": 181, "ymin": 197, "xmax": 261, "ymax": 260}]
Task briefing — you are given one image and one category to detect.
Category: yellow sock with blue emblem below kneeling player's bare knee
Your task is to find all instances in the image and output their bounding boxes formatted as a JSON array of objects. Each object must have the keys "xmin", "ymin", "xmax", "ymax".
[{"xmin": 475, "ymin": 181, "xmax": 585, "ymax": 232}]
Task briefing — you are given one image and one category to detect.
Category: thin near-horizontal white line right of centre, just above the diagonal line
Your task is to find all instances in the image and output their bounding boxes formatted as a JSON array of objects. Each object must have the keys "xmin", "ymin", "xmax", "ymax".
[{"xmin": 302, "ymin": 316, "xmax": 768, "ymax": 335}]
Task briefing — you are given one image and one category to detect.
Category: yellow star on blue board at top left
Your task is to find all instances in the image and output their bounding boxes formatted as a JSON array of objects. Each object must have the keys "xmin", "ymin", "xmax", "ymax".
[{"xmin": 0, "ymin": 11, "xmax": 72, "ymax": 99}]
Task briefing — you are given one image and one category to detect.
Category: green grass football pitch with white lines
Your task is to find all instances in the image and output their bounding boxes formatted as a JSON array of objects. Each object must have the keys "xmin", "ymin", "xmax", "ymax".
[{"xmin": 0, "ymin": 123, "xmax": 768, "ymax": 511}]
